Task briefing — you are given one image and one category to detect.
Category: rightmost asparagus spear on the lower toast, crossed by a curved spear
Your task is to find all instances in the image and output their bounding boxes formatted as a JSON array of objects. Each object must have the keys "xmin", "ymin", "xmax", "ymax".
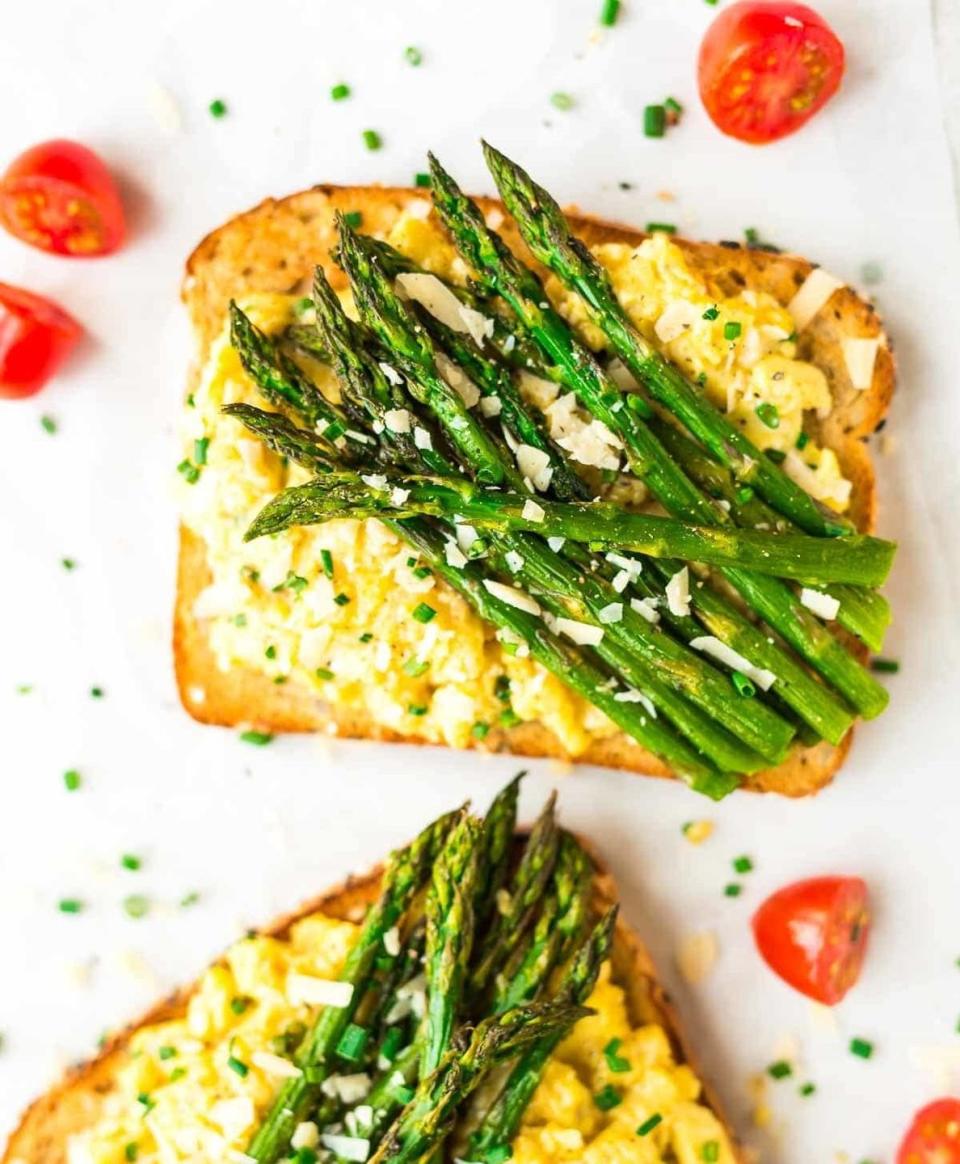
[{"xmin": 467, "ymin": 906, "xmax": 617, "ymax": 1161}]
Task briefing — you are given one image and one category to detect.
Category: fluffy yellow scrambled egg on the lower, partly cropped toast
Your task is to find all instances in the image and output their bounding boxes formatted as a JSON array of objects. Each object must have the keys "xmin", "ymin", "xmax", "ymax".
[{"xmin": 67, "ymin": 914, "xmax": 733, "ymax": 1164}]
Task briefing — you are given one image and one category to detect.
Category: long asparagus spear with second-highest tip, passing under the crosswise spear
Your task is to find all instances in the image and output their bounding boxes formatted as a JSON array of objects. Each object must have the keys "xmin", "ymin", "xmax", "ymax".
[{"xmin": 431, "ymin": 155, "xmax": 889, "ymax": 718}]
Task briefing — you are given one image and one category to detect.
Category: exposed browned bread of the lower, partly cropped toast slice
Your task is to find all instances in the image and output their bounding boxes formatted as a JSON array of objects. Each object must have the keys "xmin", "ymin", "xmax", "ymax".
[{"xmin": 0, "ymin": 838, "xmax": 742, "ymax": 1164}]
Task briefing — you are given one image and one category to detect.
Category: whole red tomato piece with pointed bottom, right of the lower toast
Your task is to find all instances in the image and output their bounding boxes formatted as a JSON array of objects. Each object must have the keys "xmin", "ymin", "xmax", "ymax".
[{"xmin": 753, "ymin": 876, "xmax": 870, "ymax": 1006}]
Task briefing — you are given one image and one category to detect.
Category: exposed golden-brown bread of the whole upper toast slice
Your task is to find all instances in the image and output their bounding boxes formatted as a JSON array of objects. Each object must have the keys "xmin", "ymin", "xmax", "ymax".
[{"xmin": 173, "ymin": 186, "xmax": 895, "ymax": 796}]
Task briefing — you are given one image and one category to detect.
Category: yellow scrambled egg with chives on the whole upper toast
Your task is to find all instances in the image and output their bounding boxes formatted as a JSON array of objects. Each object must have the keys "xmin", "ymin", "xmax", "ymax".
[{"xmin": 179, "ymin": 214, "xmax": 849, "ymax": 757}]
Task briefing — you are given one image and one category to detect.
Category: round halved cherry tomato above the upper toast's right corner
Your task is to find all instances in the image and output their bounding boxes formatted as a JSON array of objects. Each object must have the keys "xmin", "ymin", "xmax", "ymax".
[{"xmin": 698, "ymin": 0, "xmax": 844, "ymax": 144}]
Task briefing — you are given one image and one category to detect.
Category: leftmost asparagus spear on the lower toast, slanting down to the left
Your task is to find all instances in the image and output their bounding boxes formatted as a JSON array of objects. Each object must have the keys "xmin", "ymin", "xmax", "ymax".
[{"xmin": 247, "ymin": 812, "xmax": 457, "ymax": 1164}]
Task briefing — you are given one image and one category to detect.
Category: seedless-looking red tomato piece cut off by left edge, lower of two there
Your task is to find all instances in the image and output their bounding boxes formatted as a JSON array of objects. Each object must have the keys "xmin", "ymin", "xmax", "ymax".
[{"xmin": 0, "ymin": 283, "xmax": 83, "ymax": 399}]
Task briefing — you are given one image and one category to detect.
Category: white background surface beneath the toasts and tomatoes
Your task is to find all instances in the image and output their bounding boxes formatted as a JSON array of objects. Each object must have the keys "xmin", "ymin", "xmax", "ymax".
[{"xmin": 0, "ymin": 0, "xmax": 960, "ymax": 1164}]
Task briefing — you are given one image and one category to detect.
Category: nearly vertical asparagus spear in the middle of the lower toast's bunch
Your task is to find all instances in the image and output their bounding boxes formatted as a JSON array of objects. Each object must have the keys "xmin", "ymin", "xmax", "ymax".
[{"xmin": 420, "ymin": 816, "xmax": 482, "ymax": 1076}]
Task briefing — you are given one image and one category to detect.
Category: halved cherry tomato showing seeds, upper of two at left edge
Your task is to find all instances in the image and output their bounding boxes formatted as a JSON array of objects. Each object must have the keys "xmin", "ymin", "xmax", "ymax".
[{"xmin": 0, "ymin": 141, "xmax": 126, "ymax": 257}]
